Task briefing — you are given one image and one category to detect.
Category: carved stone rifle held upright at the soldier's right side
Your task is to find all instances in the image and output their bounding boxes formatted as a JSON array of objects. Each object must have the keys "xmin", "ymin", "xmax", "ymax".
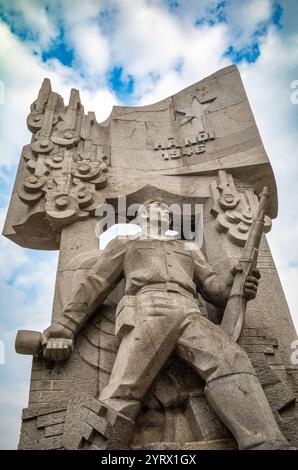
[{"xmin": 221, "ymin": 186, "xmax": 269, "ymax": 341}]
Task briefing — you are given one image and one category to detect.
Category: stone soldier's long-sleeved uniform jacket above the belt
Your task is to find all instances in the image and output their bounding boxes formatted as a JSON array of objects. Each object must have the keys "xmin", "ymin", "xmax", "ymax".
[{"xmin": 59, "ymin": 236, "xmax": 227, "ymax": 333}]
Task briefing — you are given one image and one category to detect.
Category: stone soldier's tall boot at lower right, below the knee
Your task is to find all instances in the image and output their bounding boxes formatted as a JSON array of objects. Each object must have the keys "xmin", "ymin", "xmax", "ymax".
[{"xmin": 205, "ymin": 374, "xmax": 294, "ymax": 450}]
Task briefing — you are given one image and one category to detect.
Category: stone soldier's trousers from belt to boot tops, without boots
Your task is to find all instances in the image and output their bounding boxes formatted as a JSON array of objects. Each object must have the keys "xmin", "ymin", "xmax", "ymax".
[{"xmin": 100, "ymin": 291, "xmax": 255, "ymax": 401}]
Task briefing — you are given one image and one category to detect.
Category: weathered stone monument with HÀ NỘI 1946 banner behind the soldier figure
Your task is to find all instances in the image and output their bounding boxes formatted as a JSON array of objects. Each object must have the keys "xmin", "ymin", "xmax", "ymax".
[{"xmin": 4, "ymin": 66, "xmax": 298, "ymax": 450}]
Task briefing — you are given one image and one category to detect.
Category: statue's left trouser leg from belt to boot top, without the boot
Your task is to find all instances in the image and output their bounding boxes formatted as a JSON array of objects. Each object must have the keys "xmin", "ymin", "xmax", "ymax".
[{"xmin": 100, "ymin": 291, "xmax": 183, "ymax": 419}]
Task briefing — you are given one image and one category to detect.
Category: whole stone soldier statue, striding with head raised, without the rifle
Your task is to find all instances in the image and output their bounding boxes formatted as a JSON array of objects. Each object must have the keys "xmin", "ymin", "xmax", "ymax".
[{"xmin": 42, "ymin": 201, "xmax": 291, "ymax": 450}]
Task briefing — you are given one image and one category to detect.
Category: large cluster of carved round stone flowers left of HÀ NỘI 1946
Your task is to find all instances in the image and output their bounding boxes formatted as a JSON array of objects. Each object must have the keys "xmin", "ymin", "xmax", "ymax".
[{"xmin": 18, "ymin": 98, "xmax": 107, "ymax": 219}]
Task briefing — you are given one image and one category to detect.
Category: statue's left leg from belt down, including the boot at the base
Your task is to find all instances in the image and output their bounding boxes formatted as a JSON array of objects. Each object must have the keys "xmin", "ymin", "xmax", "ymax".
[{"xmin": 81, "ymin": 292, "xmax": 183, "ymax": 449}]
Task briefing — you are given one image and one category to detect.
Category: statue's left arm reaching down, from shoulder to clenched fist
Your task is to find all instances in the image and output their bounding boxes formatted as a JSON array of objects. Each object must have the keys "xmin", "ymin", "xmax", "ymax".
[{"xmin": 42, "ymin": 238, "xmax": 127, "ymax": 360}]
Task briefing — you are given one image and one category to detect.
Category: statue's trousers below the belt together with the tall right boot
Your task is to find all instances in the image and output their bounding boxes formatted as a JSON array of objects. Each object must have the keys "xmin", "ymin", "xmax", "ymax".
[{"xmin": 100, "ymin": 291, "xmax": 289, "ymax": 449}]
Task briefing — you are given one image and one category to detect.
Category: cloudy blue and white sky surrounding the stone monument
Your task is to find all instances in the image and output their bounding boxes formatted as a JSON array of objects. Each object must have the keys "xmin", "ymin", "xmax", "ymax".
[{"xmin": 0, "ymin": 0, "xmax": 298, "ymax": 448}]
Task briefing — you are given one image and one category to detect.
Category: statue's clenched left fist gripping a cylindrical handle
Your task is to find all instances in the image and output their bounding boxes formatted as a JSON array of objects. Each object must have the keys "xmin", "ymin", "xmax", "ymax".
[{"xmin": 41, "ymin": 323, "xmax": 74, "ymax": 361}]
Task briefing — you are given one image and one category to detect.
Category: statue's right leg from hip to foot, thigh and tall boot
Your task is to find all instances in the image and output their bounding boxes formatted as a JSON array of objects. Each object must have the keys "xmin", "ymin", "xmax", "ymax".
[{"xmin": 177, "ymin": 315, "xmax": 289, "ymax": 449}]
